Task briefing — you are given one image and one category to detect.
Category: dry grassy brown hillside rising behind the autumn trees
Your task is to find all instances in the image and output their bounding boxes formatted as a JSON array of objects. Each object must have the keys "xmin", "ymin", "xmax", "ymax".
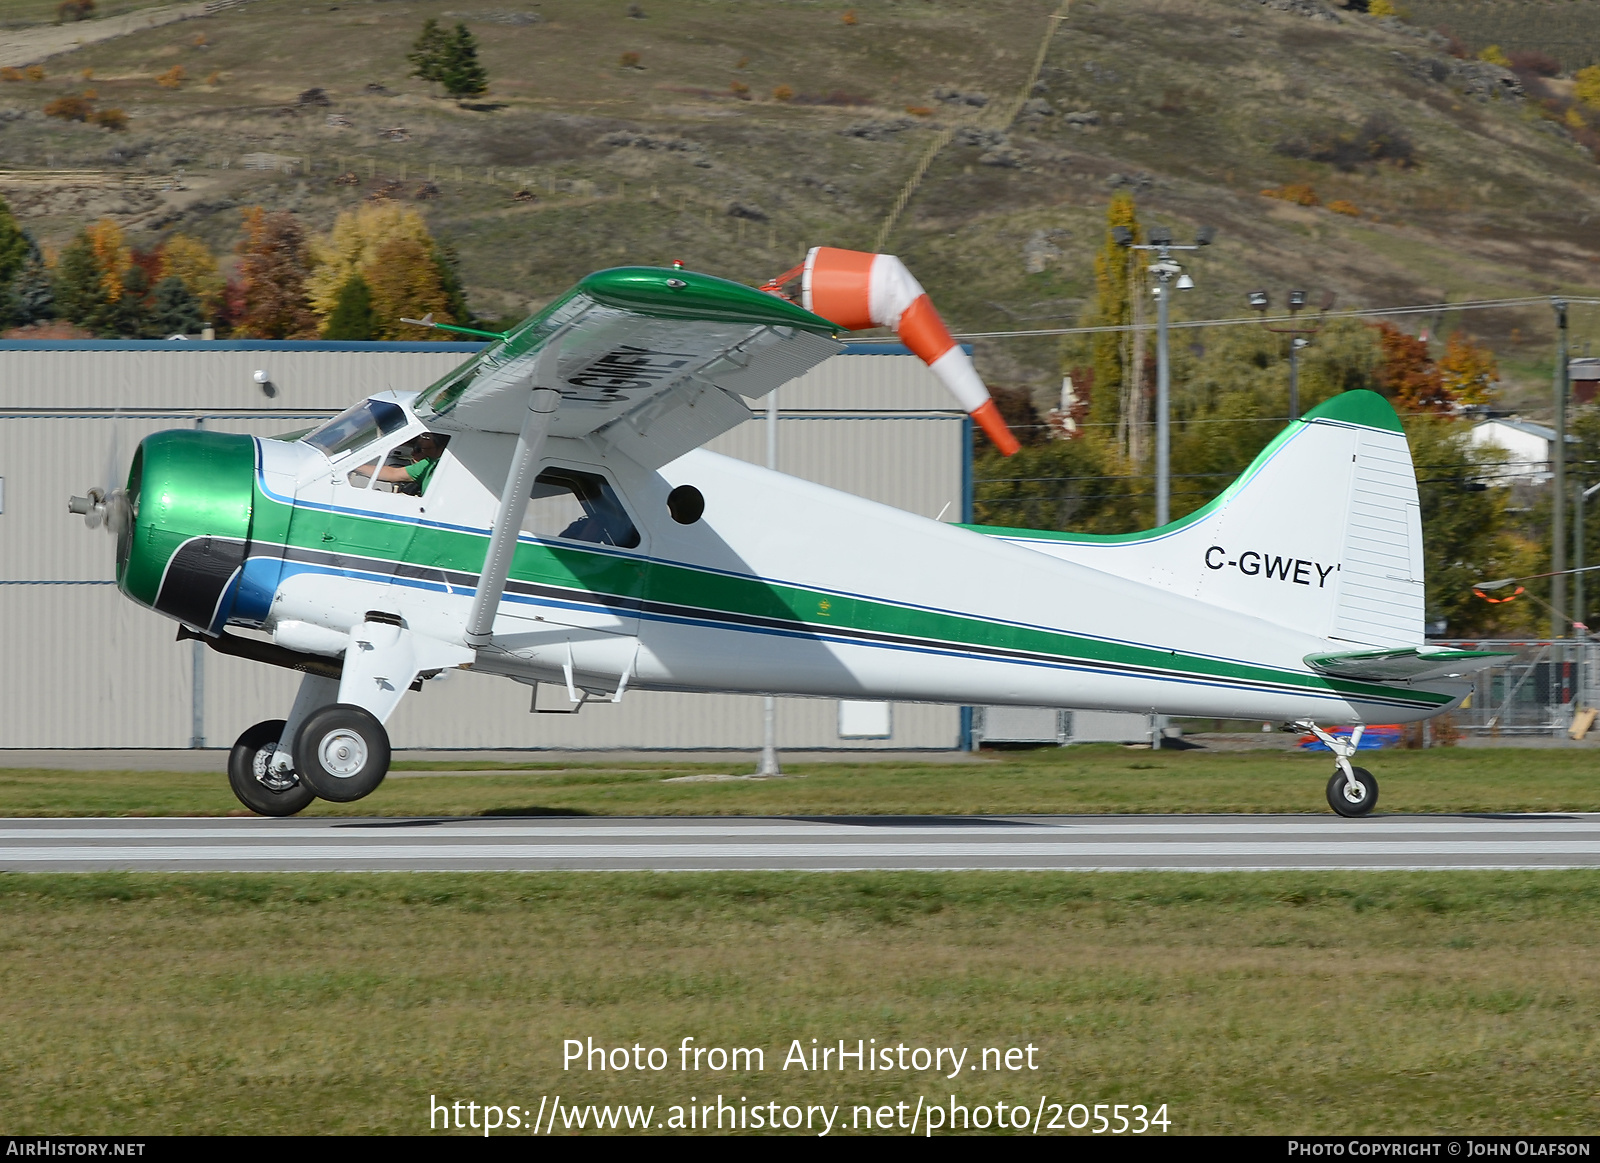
[{"xmin": 0, "ymin": 0, "xmax": 1600, "ymax": 405}]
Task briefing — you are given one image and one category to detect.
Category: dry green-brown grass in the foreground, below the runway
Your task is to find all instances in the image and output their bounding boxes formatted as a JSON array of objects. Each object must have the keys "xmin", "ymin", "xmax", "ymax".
[{"xmin": 0, "ymin": 872, "xmax": 1600, "ymax": 1136}]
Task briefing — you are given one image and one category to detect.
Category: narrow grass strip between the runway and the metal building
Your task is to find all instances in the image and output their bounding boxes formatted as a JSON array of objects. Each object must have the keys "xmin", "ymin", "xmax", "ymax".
[{"xmin": 0, "ymin": 745, "xmax": 1600, "ymax": 816}]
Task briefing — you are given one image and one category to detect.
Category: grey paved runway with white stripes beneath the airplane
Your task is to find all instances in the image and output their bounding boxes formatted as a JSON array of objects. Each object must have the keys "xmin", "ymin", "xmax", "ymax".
[{"xmin": 0, "ymin": 813, "xmax": 1600, "ymax": 872}]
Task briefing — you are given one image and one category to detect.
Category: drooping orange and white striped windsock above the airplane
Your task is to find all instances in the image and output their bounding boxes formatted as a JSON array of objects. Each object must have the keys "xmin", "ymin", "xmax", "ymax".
[{"xmin": 800, "ymin": 246, "xmax": 1019, "ymax": 456}]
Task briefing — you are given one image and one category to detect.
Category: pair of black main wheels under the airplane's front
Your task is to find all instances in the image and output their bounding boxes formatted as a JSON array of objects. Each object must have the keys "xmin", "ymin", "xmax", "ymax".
[{"xmin": 227, "ymin": 702, "xmax": 389, "ymax": 816}]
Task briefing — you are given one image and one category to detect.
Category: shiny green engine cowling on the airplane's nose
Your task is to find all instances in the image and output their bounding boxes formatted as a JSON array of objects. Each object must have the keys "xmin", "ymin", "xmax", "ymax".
[{"xmin": 117, "ymin": 430, "xmax": 256, "ymax": 632}]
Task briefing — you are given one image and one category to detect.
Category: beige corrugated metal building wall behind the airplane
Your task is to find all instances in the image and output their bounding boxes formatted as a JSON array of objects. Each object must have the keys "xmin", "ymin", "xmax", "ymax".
[{"xmin": 0, "ymin": 344, "xmax": 965, "ymax": 749}]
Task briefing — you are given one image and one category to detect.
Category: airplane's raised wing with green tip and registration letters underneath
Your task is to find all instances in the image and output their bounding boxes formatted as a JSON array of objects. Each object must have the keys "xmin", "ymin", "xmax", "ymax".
[{"xmin": 414, "ymin": 267, "xmax": 843, "ymax": 469}]
